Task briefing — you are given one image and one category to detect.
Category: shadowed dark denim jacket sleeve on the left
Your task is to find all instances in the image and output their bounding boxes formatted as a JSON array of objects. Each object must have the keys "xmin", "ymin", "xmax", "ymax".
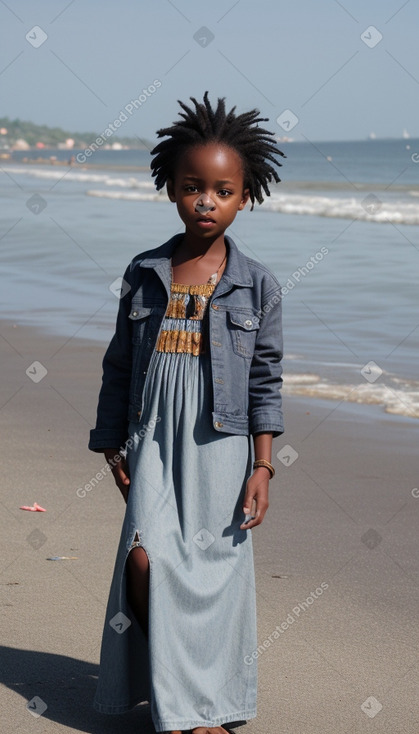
[{"xmin": 89, "ymin": 266, "xmax": 132, "ymax": 452}]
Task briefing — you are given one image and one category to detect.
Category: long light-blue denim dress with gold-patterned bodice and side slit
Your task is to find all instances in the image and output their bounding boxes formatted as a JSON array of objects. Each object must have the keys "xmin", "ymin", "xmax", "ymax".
[{"xmin": 94, "ymin": 276, "xmax": 257, "ymax": 732}]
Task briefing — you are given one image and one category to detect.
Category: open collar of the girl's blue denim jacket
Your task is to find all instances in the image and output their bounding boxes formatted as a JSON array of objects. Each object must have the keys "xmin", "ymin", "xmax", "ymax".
[{"xmin": 136, "ymin": 233, "xmax": 253, "ymax": 294}]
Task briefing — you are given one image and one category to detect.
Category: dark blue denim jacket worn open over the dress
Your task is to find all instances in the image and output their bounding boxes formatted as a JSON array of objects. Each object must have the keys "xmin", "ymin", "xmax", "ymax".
[{"xmin": 89, "ymin": 234, "xmax": 284, "ymax": 451}]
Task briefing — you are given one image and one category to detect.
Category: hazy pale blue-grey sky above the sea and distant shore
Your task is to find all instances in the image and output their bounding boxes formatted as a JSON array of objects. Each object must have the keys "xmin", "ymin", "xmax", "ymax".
[{"xmin": 0, "ymin": 0, "xmax": 419, "ymax": 141}]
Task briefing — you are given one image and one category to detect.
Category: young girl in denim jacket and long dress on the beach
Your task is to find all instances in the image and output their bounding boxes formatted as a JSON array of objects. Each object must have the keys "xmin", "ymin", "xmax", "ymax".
[{"xmin": 89, "ymin": 92, "xmax": 283, "ymax": 734}]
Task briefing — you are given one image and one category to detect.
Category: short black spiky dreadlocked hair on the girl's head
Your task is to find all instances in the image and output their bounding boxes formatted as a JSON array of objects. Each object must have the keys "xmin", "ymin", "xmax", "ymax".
[{"xmin": 151, "ymin": 92, "xmax": 286, "ymax": 209}]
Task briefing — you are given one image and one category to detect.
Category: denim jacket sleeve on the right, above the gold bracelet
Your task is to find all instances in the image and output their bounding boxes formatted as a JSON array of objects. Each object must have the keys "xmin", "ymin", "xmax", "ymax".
[{"xmin": 249, "ymin": 284, "xmax": 284, "ymax": 438}]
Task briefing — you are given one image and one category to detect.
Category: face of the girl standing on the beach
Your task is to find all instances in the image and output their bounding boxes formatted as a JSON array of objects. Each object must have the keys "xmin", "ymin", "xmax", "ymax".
[{"xmin": 167, "ymin": 143, "xmax": 249, "ymax": 240}]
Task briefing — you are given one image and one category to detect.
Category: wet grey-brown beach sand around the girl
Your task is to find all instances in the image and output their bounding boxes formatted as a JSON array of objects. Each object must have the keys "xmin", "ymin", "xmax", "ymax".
[{"xmin": 0, "ymin": 322, "xmax": 419, "ymax": 734}]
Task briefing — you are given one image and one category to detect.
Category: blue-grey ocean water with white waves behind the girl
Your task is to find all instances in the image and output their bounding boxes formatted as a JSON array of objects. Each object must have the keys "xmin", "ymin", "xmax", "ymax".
[{"xmin": 0, "ymin": 139, "xmax": 419, "ymax": 419}]
